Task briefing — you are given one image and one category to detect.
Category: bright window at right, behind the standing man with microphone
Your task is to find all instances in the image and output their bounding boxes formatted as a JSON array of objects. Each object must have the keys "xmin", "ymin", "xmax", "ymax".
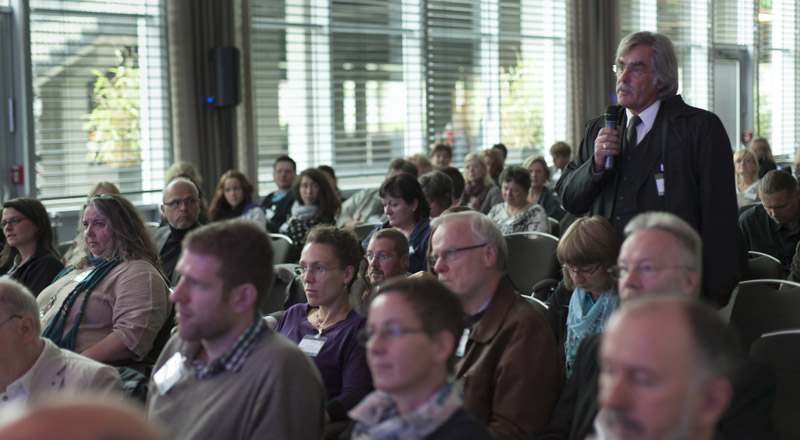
[{"xmin": 620, "ymin": 0, "xmax": 800, "ymax": 156}]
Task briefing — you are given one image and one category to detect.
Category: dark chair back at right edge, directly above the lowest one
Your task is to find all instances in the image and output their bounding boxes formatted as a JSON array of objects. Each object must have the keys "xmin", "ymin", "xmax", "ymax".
[{"xmin": 730, "ymin": 280, "xmax": 800, "ymax": 350}]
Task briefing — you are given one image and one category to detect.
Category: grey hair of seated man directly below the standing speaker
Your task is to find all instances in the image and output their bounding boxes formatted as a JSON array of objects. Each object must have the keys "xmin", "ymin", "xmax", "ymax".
[{"xmin": 625, "ymin": 212, "xmax": 703, "ymax": 287}]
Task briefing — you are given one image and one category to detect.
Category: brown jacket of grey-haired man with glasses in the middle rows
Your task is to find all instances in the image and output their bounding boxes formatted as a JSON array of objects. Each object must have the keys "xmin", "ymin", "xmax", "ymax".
[{"xmin": 456, "ymin": 278, "xmax": 564, "ymax": 439}]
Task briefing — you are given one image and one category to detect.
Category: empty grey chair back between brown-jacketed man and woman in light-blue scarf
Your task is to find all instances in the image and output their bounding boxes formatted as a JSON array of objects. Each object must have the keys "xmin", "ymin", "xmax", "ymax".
[{"xmin": 505, "ymin": 232, "xmax": 560, "ymax": 295}]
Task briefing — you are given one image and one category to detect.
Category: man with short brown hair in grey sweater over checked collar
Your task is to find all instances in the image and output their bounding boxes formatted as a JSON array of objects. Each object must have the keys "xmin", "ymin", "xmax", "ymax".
[{"xmin": 146, "ymin": 220, "xmax": 324, "ymax": 440}]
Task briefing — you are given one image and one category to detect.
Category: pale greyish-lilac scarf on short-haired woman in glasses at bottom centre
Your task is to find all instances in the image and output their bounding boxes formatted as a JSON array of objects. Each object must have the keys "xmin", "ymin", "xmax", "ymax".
[{"xmin": 348, "ymin": 382, "xmax": 461, "ymax": 440}]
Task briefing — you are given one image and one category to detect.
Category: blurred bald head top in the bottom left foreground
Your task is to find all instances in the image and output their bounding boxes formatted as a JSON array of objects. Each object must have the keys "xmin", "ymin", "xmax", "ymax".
[{"xmin": 0, "ymin": 397, "xmax": 166, "ymax": 440}]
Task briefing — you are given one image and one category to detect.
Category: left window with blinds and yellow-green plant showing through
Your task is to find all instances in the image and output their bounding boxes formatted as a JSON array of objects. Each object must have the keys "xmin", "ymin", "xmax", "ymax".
[{"xmin": 30, "ymin": 0, "xmax": 171, "ymax": 201}]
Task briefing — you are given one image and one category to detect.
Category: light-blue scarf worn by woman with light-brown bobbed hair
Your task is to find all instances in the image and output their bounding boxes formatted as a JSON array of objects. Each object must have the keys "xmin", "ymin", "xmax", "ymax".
[{"xmin": 564, "ymin": 287, "xmax": 619, "ymax": 378}]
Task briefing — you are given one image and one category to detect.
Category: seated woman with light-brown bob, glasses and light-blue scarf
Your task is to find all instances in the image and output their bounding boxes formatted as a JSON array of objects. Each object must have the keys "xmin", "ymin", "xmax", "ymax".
[{"xmin": 547, "ymin": 215, "xmax": 619, "ymax": 378}]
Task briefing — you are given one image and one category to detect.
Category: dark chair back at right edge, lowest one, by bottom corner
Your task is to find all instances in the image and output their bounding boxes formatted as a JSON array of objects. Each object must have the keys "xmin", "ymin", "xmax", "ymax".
[{"xmin": 750, "ymin": 329, "xmax": 800, "ymax": 438}]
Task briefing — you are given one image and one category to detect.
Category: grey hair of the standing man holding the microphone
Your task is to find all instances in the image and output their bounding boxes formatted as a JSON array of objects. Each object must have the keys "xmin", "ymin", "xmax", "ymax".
[{"xmin": 614, "ymin": 31, "xmax": 678, "ymax": 101}]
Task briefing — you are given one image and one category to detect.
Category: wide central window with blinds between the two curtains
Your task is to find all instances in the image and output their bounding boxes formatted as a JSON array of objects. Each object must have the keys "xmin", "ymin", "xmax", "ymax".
[{"xmin": 251, "ymin": 0, "xmax": 566, "ymax": 193}]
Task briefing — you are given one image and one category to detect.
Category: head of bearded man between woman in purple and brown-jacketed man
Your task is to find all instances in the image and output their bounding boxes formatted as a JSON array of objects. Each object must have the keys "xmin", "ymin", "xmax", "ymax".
[{"xmin": 367, "ymin": 228, "xmax": 409, "ymax": 286}]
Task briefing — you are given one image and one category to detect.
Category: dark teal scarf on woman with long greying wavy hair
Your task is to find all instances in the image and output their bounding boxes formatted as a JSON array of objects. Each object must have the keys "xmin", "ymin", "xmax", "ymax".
[{"xmin": 42, "ymin": 254, "xmax": 120, "ymax": 351}]
